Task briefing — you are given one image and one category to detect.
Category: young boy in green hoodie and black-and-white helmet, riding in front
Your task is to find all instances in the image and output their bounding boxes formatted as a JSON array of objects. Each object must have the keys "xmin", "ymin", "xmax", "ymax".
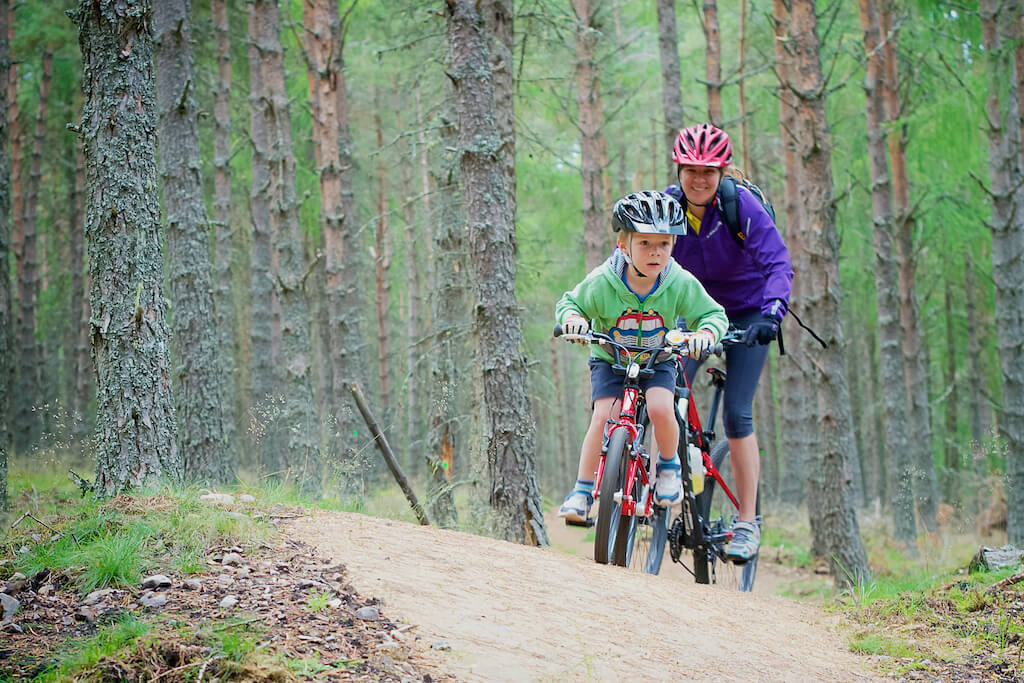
[{"xmin": 555, "ymin": 191, "xmax": 729, "ymax": 522}]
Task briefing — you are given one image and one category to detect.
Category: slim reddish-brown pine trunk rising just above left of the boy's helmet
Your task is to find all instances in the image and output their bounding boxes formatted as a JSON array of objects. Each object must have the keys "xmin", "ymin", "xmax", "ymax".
[{"xmin": 572, "ymin": 0, "xmax": 611, "ymax": 272}]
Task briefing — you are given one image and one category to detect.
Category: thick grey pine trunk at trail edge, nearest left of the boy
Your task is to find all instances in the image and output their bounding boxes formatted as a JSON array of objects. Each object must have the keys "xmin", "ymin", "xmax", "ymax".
[{"xmin": 446, "ymin": 0, "xmax": 548, "ymax": 545}]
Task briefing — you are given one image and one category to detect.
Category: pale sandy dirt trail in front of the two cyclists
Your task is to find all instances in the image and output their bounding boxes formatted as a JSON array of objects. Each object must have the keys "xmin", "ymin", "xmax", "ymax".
[{"xmin": 291, "ymin": 513, "xmax": 876, "ymax": 682}]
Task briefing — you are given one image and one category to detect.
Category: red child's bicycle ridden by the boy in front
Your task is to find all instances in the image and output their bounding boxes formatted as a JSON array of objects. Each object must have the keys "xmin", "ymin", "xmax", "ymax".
[{"xmin": 554, "ymin": 326, "xmax": 689, "ymax": 573}]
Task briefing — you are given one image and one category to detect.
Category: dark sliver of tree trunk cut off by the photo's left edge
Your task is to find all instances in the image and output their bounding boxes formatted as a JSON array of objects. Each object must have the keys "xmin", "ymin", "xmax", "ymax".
[{"xmin": 0, "ymin": 0, "xmax": 13, "ymax": 512}]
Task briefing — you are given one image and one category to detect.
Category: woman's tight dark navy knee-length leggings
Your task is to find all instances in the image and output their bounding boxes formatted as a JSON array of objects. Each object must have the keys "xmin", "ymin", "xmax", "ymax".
[{"xmin": 683, "ymin": 313, "xmax": 771, "ymax": 438}]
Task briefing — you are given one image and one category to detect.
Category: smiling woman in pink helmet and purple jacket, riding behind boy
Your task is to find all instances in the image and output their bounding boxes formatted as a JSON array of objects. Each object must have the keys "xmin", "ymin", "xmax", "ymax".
[{"xmin": 666, "ymin": 123, "xmax": 793, "ymax": 561}]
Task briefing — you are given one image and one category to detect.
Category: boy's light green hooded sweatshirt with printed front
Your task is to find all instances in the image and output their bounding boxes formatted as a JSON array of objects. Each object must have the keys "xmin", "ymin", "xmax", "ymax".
[{"xmin": 555, "ymin": 249, "xmax": 729, "ymax": 362}]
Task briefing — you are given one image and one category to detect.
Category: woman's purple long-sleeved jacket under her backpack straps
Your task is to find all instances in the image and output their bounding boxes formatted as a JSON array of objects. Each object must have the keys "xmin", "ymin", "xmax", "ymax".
[{"xmin": 665, "ymin": 185, "xmax": 793, "ymax": 319}]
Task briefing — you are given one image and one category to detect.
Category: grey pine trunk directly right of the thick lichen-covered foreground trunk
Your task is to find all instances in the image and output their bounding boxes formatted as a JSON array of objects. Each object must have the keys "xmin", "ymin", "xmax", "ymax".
[{"xmin": 153, "ymin": 0, "xmax": 236, "ymax": 483}]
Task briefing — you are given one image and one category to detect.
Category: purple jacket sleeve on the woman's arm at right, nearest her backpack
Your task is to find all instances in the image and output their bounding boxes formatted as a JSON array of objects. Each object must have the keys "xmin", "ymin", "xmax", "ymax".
[{"xmin": 739, "ymin": 187, "xmax": 793, "ymax": 319}]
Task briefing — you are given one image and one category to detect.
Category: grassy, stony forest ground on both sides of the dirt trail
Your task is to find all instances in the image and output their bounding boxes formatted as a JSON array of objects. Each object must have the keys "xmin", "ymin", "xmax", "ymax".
[{"xmin": 6, "ymin": 456, "xmax": 1024, "ymax": 681}]
